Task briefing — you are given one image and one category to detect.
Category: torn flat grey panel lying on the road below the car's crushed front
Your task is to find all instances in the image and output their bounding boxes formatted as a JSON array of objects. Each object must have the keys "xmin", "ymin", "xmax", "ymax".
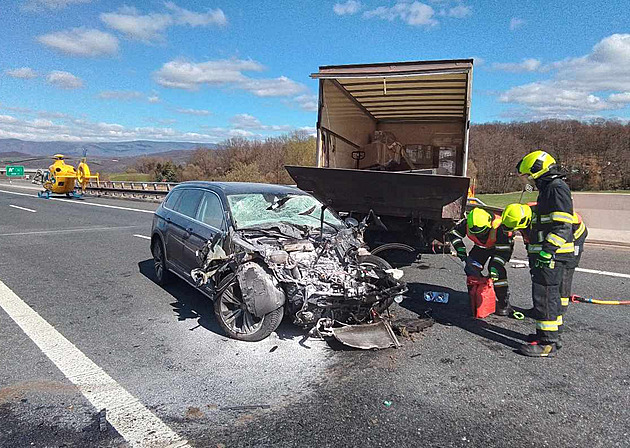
[{"xmin": 330, "ymin": 320, "xmax": 401, "ymax": 350}]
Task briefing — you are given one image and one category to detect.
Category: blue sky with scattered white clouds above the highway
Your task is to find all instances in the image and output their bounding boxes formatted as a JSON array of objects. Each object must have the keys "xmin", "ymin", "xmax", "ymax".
[{"xmin": 0, "ymin": 0, "xmax": 630, "ymax": 142}]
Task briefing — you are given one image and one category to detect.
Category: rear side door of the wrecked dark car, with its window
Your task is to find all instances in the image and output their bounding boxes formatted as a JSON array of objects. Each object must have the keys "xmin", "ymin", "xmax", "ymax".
[{"xmin": 167, "ymin": 188, "xmax": 203, "ymax": 276}]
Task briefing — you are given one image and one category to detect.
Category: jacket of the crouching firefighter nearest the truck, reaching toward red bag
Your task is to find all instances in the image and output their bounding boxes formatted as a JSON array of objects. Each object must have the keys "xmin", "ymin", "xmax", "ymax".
[{"xmin": 446, "ymin": 215, "xmax": 514, "ymax": 266}]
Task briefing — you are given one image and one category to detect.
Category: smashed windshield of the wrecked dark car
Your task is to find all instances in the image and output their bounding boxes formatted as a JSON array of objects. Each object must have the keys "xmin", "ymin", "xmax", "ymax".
[{"xmin": 227, "ymin": 193, "xmax": 345, "ymax": 230}]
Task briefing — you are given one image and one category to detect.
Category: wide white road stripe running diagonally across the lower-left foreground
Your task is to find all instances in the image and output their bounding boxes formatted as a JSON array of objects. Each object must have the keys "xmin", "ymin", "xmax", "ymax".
[{"xmin": 0, "ymin": 281, "xmax": 190, "ymax": 448}]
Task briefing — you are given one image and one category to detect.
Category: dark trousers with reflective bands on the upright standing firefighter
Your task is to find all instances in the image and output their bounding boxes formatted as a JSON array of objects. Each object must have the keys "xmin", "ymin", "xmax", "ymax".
[{"xmin": 529, "ymin": 254, "xmax": 570, "ymax": 343}]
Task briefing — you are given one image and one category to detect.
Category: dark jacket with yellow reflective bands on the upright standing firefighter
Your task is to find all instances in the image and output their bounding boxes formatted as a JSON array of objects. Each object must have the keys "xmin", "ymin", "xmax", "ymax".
[{"xmin": 527, "ymin": 170, "xmax": 575, "ymax": 260}]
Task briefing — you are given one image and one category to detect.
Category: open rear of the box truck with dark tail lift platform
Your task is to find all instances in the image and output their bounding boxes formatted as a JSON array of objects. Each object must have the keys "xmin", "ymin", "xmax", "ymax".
[{"xmin": 287, "ymin": 59, "xmax": 473, "ymax": 258}]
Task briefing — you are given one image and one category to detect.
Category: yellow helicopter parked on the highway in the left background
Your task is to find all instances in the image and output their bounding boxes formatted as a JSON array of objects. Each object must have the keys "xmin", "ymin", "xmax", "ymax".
[{"xmin": 33, "ymin": 151, "xmax": 99, "ymax": 199}]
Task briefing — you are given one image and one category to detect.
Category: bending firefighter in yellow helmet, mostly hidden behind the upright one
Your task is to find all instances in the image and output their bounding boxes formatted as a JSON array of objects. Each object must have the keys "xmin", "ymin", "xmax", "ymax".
[{"xmin": 501, "ymin": 202, "xmax": 588, "ymax": 349}]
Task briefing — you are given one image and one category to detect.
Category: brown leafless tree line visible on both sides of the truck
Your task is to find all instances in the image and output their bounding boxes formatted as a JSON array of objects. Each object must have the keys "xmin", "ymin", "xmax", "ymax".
[{"xmin": 133, "ymin": 120, "xmax": 630, "ymax": 193}]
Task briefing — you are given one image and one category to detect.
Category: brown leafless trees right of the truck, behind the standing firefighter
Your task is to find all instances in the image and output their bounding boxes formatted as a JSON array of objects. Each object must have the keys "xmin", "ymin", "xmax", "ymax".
[{"xmin": 468, "ymin": 120, "xmax": 630, "ymax": 193}]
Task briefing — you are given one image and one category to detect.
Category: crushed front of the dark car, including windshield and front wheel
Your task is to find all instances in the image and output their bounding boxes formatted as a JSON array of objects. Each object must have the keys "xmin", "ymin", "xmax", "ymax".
[{"xmin": 192, "ymin": 189, "xmax": 407, "ymax": 348}]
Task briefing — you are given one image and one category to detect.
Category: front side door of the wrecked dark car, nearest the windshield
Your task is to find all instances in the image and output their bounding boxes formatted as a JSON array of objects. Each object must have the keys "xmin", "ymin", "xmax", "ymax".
[{"xmin": 182, "ymin": 190, "xmax": 225, "ymax": 273}]
